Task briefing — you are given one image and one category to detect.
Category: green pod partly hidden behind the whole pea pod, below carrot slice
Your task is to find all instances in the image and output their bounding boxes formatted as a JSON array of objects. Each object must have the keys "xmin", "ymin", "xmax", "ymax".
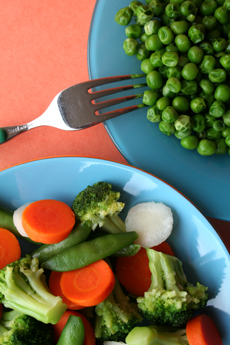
[{"xmin": 30, "ymin": 222, "xmax": 91, "ymax": 264}]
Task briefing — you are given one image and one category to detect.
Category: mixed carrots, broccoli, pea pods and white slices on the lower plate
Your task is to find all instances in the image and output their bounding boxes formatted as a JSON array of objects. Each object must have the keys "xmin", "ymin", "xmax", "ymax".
[{"xmin": 0, "ymin": 182, "xmax": 222, "ymax": 345}]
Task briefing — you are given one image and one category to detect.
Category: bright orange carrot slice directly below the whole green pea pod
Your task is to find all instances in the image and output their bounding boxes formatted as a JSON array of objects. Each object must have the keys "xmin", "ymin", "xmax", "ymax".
[{"xmin": 61, "ymin": 260, "xmax": 115, "ymax": 307}]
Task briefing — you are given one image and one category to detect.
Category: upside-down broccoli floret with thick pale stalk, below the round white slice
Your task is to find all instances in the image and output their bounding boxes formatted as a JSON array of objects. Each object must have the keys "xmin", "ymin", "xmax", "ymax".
[{"xmin": 137, "ymin": 249, "xmax": 208, "ymax": 327}]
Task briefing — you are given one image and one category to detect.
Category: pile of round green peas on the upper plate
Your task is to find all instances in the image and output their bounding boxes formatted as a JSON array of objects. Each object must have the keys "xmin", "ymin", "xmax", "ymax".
[{"xmin": 115, "ymin": 0, "xmax": 230, "ymax": 156}]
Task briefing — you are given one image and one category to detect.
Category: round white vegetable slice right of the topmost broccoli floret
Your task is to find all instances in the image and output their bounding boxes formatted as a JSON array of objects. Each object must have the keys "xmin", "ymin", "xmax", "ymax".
[{"xmin": 125, "ymin": 201, "xmax": 173, "ymax": 248}]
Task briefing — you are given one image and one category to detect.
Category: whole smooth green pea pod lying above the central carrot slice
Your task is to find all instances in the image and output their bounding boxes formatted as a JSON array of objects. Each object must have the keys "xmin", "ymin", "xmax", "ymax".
[{"xmin": 41, "ymin": 231, "xmax": 138, "ymax": 272}]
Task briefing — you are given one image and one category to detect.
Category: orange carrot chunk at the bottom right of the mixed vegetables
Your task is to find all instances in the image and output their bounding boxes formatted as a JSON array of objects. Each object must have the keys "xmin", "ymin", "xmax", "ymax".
[{"xmin": 186, "ymin": 314, "xmax": 223, "ymax": 345}]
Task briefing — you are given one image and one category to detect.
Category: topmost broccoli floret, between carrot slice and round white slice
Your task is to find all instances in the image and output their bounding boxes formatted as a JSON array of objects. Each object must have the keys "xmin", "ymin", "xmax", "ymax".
[{"xmin": 72, "ymin": 182, "xmax": 126, "ymax": 233}]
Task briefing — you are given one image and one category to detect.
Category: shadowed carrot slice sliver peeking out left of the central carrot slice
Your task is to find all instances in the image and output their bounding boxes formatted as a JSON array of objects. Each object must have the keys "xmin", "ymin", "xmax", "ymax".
[{"xmin": 49, "ymin": 271, "xmax": 83, "ymax": 310}]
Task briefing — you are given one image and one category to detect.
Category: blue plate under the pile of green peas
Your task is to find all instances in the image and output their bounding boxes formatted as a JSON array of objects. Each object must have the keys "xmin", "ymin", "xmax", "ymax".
[{"xmin": 88, "ymin": 0, "xmax": 230, "ymax": 221}]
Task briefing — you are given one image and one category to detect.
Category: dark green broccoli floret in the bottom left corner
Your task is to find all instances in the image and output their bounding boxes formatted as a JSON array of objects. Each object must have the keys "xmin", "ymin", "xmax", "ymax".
[{"xmin": 0, "ymin": 310, "xmax": 55, "ymax": 345}]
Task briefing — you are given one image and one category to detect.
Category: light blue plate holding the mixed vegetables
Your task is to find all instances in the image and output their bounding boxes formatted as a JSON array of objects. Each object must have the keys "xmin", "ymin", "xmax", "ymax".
[{"xmin": 0, "ymin": 157, "xmax": 230, "ymax": 345}]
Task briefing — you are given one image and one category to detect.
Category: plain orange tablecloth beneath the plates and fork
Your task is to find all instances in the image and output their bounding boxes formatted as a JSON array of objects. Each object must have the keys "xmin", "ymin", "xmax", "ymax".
[{"xmin": 0, "ymin": 0, "xmax": 230, "ymax": 248}]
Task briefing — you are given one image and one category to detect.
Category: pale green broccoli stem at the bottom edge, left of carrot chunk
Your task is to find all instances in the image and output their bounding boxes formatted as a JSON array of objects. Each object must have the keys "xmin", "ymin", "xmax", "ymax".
[{"xmin": 125, "ymin": 326, "xmax": 189, "ymax": 345}]
